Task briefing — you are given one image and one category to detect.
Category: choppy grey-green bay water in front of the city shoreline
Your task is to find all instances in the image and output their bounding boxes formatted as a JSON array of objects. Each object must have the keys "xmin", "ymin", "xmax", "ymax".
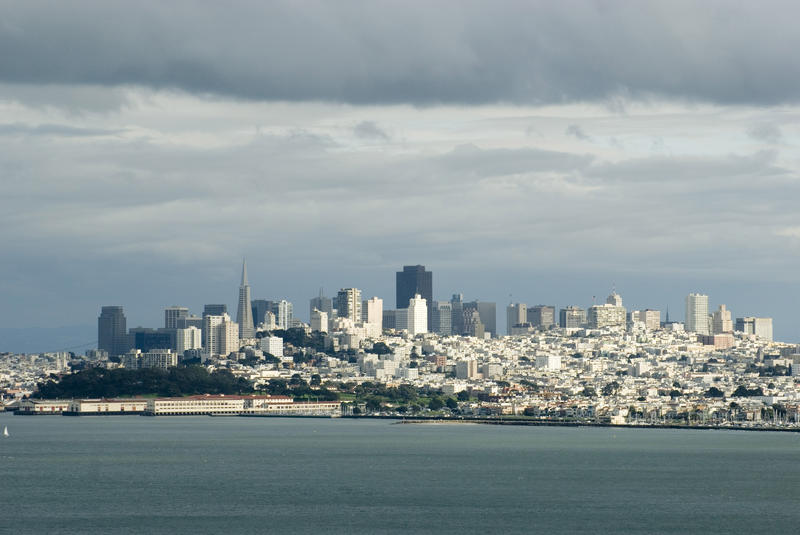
[{"xmin": 0, "ymin": 414, "xmax": 800, "ymax": 535}]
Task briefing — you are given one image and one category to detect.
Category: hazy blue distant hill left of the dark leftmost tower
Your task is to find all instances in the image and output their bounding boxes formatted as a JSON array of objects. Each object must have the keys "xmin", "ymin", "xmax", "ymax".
[{"xmin": 0, "ymin": 325, "xmax": 97, "ymax": 353}]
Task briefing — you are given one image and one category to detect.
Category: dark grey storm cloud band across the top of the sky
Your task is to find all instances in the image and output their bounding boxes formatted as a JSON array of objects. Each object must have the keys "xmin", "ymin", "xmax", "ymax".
[{"xmin": 0, "ymin": 1, "xmax": 800, "ymax": 105}]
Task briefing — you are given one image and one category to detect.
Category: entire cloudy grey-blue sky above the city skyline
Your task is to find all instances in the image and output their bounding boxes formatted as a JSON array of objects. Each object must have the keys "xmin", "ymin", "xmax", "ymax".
[{"xmin": 0, "ymin": 0, "xmax": 800, "ymax": 351}]
